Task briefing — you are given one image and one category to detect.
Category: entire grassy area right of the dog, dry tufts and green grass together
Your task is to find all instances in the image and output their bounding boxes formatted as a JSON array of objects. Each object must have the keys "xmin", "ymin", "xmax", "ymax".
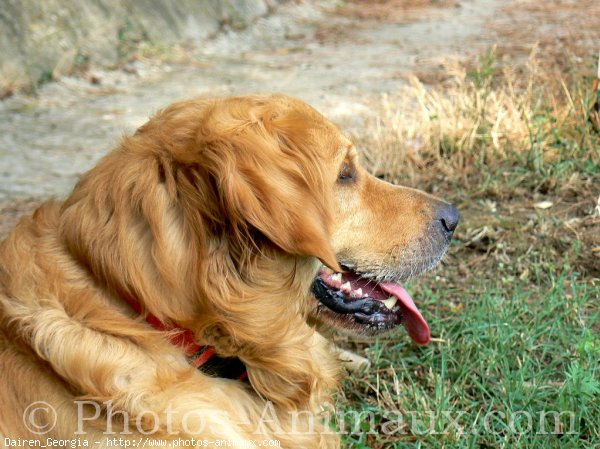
[{"xmin": 338, "ymin": 52, "xmax": 600, "ymax": 449}]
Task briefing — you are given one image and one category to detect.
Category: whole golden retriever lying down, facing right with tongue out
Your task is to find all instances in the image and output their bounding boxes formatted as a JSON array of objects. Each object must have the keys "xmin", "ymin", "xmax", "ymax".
[{"xmin": 0, "ymin": 95, "xmax": 458, "ymax": 448}]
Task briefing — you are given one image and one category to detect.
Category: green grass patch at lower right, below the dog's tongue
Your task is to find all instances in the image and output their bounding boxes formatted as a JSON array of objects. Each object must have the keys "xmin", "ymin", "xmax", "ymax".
[{"xmin": 340, "ymin": 273, "xmax": 600, "ymax": 448}]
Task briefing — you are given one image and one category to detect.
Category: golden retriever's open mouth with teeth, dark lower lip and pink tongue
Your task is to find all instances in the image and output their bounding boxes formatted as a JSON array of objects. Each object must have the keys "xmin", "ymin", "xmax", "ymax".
[{"xmin": 313, "ymin": 267, "xmax": 430, "ymax": 345}]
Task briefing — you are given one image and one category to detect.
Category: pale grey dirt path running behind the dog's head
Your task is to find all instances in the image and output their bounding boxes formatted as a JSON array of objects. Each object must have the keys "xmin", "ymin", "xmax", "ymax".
[{"xmin": 0, "ymin": 0, "xmax": 510, "ymax": 204}]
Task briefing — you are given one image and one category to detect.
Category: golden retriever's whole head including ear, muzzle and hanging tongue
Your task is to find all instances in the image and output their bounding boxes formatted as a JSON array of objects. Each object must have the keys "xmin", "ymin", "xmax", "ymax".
[{"xmin": 176, "ymin": 96, "xmax": 458, "ymax": 344}]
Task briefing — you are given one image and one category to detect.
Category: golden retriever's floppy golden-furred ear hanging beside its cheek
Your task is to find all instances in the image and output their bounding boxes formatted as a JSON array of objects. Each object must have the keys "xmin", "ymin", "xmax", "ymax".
[{"xmin": 197, "ymin": 107, "xmax": 341, "ymax": 271}]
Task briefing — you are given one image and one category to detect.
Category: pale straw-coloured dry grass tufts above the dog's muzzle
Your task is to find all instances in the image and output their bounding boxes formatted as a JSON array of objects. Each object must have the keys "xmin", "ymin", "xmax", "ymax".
[{"xmin": 361, "ymin": 52, "xmax": 600, "ymax": 193}]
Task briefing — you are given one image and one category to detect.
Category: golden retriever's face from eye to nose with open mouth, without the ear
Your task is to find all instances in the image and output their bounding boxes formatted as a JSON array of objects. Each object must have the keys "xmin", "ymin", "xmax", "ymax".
[{"xmin": 313, "ymin": 142, "xmax": 459, "ymax": 344}]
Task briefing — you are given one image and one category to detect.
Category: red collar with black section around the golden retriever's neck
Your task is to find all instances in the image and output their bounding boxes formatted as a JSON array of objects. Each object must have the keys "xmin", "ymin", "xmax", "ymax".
[{"xmin": 125, "ymin": 296, "xmax": 248, "ymax": 381}]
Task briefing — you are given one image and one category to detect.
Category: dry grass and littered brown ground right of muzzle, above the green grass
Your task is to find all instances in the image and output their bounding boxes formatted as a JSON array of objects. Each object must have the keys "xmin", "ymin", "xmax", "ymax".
[{"xmin": 358, "ymin": 53, "xmax": 600, "ymax": 285}]
